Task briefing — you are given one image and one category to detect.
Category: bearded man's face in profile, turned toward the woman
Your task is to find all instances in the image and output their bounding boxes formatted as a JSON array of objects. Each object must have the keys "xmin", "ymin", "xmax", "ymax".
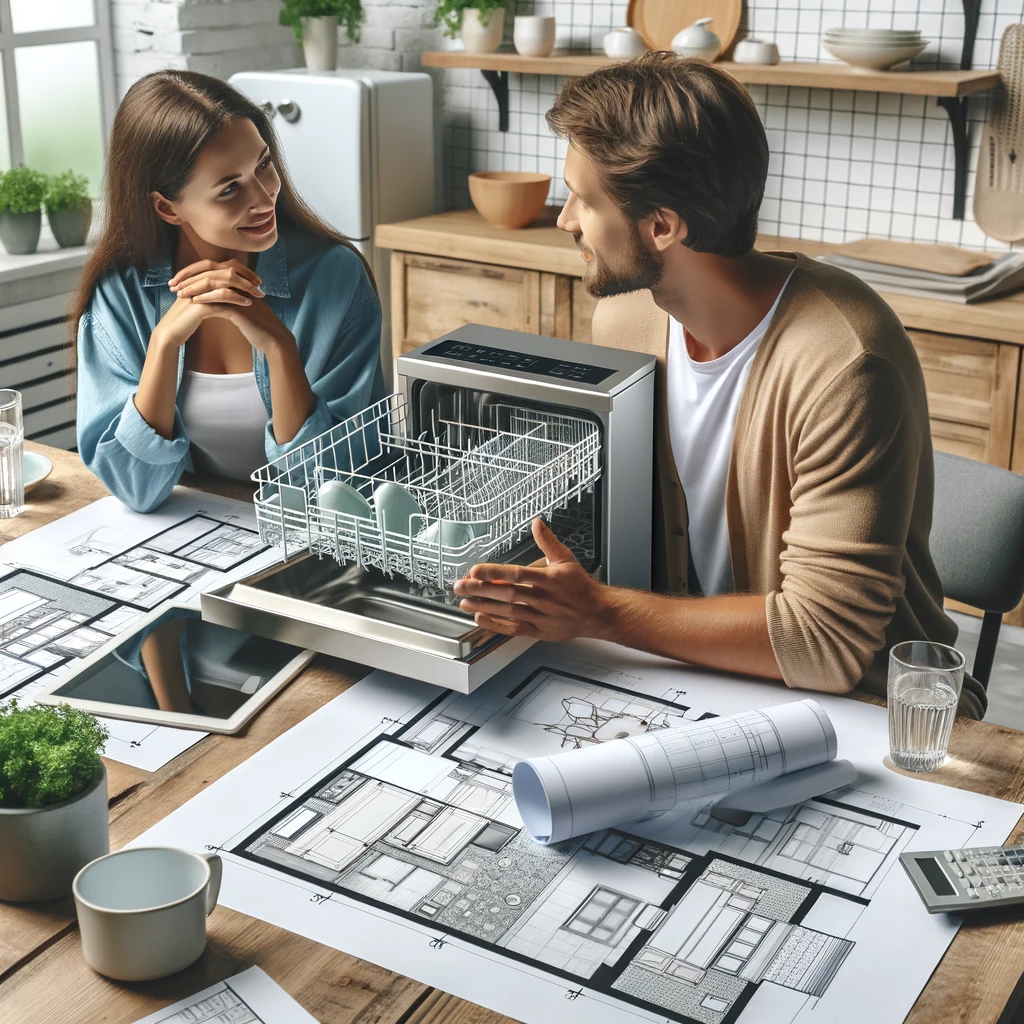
[{"xmin": 558, "ymin": 145, "xmax": 663, "ymax": 298}]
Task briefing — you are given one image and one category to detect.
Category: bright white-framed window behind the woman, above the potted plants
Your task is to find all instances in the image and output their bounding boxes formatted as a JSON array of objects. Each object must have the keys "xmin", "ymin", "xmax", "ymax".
[{"xmin": 0, "ymin": 0, "xmax": 116, "ymax": 196}]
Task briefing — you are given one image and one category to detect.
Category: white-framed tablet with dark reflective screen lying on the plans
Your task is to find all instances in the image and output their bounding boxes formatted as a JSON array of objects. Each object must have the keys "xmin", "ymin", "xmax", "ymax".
[{"xmin": 36, "ymin": 604, "xmax": 314, "ymax": 732}]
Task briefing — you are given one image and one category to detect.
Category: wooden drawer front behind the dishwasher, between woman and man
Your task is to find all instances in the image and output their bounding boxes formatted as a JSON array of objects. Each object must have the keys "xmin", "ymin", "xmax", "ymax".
[{"xmin": 391, "ymin": 253, "xmax": 541, "ymax": 356}]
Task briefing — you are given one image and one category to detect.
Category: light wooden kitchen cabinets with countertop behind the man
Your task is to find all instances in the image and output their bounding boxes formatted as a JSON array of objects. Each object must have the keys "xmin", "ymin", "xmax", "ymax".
[{"xmin": 376, "ymin": 207, "xmax": 1024, "ymax": 626}]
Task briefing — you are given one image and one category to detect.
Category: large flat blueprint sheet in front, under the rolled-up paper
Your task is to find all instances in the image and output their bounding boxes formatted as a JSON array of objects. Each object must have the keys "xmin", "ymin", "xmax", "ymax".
[{"xmin": 136, "ymin": 641, "xmax": 1021, "ymax": 1024}]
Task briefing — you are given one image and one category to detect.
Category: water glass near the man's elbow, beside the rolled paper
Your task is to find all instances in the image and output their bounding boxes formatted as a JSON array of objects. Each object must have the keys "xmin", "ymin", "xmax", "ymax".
[{"xmin": 889, "ymin": 640, "xmax": 964, "ymax": 772}]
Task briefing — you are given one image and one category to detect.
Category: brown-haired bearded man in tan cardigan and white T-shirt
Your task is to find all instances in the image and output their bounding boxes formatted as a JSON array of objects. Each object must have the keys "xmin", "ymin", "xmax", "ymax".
[{"xmin": 456, "ymin": 53, "xmax": 985, "ymax": 718}]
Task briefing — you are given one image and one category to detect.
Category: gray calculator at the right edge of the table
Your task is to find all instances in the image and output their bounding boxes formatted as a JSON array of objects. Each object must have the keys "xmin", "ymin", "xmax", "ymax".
[{"xmin": 899, "ymin": 846, "xmax": 1024, "ymax": 913}]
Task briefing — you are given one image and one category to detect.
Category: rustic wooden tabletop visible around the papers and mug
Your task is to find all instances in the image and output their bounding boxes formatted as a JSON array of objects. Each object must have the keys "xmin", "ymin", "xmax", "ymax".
[{"xmin": 6, "ymin": 442, "xmax": 1024, "ymax": 1024}]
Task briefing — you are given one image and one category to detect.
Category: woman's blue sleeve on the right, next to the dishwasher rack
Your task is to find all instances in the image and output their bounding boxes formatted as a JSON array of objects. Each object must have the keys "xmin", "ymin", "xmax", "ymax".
[{"xmin": 265, "ymin": 262, "xmax": 384, "ymax": 462}]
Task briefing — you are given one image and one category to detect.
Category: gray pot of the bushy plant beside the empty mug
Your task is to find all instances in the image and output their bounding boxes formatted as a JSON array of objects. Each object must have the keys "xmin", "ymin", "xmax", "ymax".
[{"xmin": 0, "ymin": 768, "xmax": 111, "ymax": 903}]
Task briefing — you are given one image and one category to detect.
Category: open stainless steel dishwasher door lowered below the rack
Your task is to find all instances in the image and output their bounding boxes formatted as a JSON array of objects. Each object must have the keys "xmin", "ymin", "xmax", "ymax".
[{"xmin": 201, "ymin": 555, "xmax": 534, "ymax": 693}]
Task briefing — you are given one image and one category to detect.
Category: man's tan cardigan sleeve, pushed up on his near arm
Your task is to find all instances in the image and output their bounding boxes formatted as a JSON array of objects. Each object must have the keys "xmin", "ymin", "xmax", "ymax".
[{"xmin": 766, "ymin": 354, "xmax": 927, "ymax": 692}]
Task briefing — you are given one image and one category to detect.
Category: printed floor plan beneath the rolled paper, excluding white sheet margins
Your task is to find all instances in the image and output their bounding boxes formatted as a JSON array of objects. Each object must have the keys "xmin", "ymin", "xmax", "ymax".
[{"xmin": 232, "ymin": 668, "xmax": 915, "ymax": 1024}]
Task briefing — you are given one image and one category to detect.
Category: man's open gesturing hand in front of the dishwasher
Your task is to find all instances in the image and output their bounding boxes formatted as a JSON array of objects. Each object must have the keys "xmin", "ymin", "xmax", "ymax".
[{"xmin": 455, "ymin": 519, "xmax": 607, "ymax": 641}]
